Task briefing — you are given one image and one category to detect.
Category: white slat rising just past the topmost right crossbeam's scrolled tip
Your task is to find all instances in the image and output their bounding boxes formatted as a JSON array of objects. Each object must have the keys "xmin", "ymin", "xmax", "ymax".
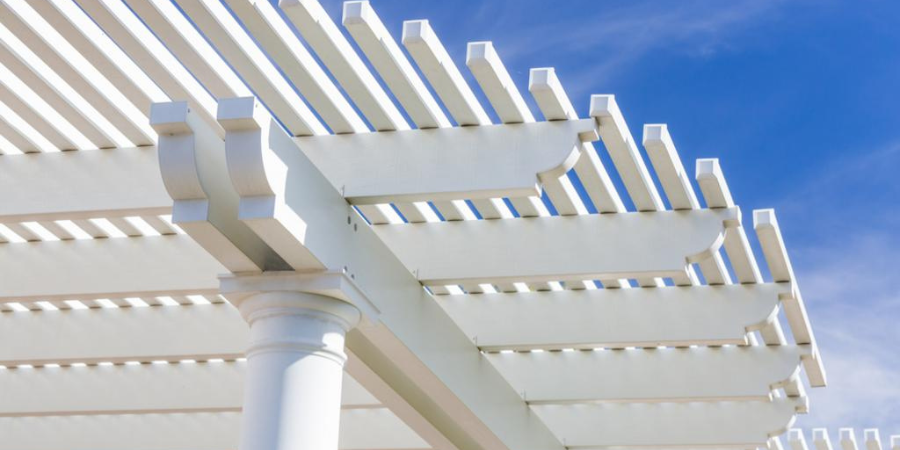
[{"xmin": 590, "ymin": 95, "xmax": 665, "ymax": 211}]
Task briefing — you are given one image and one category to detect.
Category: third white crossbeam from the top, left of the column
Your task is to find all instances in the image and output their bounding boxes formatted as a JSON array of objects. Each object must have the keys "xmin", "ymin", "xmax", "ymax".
[{"xmin": 0, "ymin": 297, "xmax": 249, "ymax": 367}]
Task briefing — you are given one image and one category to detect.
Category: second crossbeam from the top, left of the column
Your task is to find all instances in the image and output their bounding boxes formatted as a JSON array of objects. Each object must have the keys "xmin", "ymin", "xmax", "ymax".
[{"xmin": 0, "ymin": 235, "xmax": 227, "ymax": 302}]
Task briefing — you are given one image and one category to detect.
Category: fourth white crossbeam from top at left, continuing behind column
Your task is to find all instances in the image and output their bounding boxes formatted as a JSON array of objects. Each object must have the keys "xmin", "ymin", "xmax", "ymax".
[{"xmin": 0, "ymin": 361, "xmax": 379, "ymax": 417}]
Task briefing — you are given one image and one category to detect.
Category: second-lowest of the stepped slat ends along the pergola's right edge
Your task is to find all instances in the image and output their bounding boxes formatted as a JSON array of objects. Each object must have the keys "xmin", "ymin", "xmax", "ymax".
[{"xmin": 696, "ymin": 159, "xmax": 762, "ymax": 283}]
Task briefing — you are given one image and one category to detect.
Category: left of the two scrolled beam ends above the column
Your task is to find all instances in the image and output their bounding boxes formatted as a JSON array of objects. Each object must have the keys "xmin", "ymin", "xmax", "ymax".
[{"xmin": 150, "ymin": 102, "xmax": 287, "ymax": 273}]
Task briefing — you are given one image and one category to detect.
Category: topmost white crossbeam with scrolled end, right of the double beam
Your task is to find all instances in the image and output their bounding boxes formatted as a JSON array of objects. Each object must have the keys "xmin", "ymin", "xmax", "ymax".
[{"xmin": 302, "ymin": 119, "xmax": 597, "ymax": 205}]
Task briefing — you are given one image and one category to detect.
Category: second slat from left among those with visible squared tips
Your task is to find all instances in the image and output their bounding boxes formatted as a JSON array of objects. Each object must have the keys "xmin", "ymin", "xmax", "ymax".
[{"xmin": 401, "ymin": 20, "xmax": 491, "ymax": 126}]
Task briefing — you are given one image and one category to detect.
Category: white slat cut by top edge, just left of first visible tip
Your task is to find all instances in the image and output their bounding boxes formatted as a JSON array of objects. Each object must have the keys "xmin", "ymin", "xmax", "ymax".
[{"xmin": 279, "ymin": 0, "xmax": 409, "ymax": 131}]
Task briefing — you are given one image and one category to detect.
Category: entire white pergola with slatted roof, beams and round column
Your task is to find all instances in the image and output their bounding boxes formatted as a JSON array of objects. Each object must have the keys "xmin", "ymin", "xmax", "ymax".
[{"xmin": 0, "ymin": 0, "xmax": 828, "ymax": 450}]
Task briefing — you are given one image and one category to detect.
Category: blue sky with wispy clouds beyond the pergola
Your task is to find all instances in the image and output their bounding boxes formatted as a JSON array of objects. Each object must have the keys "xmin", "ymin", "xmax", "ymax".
[{"xmin": 312, "ymin": 0, "xmax": 900, "ymax": 432}]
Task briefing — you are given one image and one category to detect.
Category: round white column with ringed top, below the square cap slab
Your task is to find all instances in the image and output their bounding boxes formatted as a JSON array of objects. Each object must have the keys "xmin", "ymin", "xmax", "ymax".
[{"xmin": 238, "ymin": 292, "xmax": 360, "ymax": 450}]
